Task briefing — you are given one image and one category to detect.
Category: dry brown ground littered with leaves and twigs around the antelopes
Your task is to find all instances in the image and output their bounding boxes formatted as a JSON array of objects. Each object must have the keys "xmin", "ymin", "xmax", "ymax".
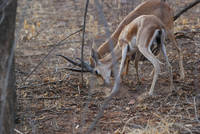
[{"xmin": 15, "ymin": 0, "xmax": 200, "ymax": 134}]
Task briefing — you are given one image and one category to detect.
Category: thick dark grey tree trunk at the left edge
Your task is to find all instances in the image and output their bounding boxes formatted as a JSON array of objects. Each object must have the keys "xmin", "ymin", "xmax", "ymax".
[{"xmin": 0, "ymin": 0, "xmax": 17, "ymax": 134}]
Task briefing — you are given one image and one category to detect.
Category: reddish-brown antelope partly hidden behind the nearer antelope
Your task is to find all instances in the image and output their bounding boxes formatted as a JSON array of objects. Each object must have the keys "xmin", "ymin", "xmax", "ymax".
[{"xmin": 89, "ymin": 0, "xmax": 185, "ymax": 80}]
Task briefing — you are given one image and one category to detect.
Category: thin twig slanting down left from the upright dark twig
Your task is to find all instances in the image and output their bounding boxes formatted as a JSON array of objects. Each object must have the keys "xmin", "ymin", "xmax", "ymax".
[{"xmin": 22, "ymin": 28, "xmax": 82, "ymax": 83}]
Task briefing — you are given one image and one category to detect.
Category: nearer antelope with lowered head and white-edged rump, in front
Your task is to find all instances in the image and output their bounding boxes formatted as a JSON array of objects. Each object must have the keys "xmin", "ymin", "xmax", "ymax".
[{"xmin": 91, "ymin": 15, "xmax": 174, "ymax": 95}]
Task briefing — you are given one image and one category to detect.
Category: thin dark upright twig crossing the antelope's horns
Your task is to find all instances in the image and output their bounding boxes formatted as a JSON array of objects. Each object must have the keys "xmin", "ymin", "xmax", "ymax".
[{"xmin": 81, "ymin": 0, "xmax": 89, "ymax": 85}]
